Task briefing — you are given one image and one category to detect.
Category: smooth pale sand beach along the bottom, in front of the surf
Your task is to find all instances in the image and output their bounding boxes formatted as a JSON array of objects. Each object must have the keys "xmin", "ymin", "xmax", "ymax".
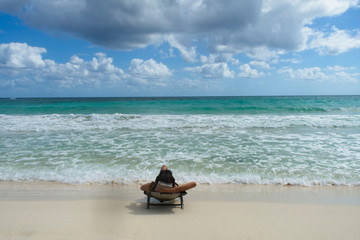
[{"xmin": 0, "ymin": 182, "xmax": 360, "ymax": 240}]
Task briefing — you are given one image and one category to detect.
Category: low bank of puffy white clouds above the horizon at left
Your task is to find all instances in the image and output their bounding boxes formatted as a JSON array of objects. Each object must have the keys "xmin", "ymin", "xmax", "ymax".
[{"xmin": 0, "ymin": 43, "xmax": 173, "ymax": 88}]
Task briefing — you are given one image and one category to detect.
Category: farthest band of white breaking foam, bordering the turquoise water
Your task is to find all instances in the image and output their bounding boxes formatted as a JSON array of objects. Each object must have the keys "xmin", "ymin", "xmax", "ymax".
[{"xmin": 0, "ymin": 114, "xmax": 360, "ymax": 132}]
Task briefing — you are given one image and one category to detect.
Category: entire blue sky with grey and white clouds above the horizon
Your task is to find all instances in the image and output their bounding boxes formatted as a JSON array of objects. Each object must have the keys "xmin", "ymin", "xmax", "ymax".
[{"xmin": 0, "ymin": 0, "xmax": 360, "ymax": 97}]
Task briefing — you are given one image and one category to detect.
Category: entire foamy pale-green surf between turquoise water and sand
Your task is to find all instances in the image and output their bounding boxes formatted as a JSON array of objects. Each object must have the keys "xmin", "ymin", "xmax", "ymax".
[{"xmin": 0, "ymin": 113, "xmax": 360, "ymax": 186}]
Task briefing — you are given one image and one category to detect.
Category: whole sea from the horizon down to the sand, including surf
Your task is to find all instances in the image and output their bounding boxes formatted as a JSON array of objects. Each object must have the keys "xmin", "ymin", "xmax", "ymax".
[{"xmin": 0, "ymin": 96, "xmax": 360, "ymax": 186}]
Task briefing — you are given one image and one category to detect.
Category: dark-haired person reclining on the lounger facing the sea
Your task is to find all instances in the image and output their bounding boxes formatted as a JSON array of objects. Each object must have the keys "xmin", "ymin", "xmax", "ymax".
[{"xmin": 140, "ymin": 165, "xmax": 196, "ymax": 193}]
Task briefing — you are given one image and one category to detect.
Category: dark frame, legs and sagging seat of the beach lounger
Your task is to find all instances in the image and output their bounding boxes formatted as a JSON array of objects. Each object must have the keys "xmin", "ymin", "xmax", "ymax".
[{"xmin": 144, "ymin": 192, "xmax": 187, "ymax": 209}]
